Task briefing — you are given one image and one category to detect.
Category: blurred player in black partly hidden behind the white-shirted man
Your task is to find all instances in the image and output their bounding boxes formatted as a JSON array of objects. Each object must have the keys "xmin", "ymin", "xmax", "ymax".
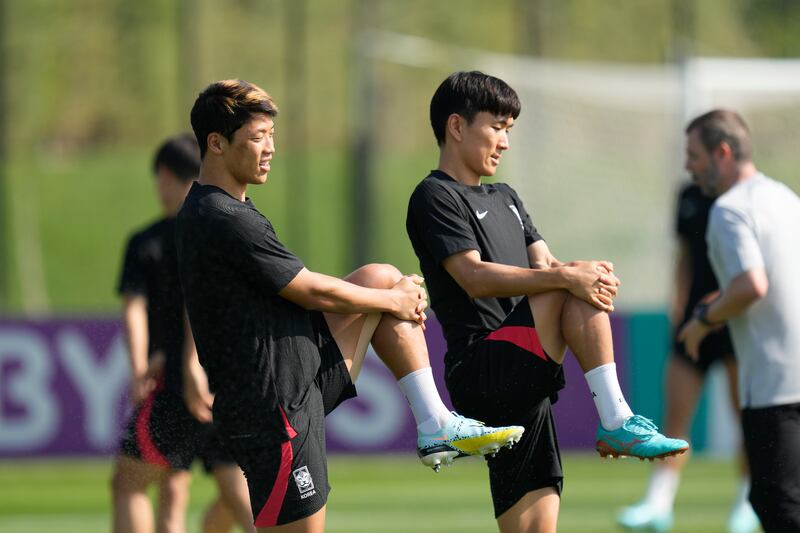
[{"xmin": 617, "ymin": 184, "xmax": 758, "ymax": 533}]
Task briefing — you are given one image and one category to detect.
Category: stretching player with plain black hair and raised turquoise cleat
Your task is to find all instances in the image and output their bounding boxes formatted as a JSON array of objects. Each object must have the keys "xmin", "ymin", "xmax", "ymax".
[{"xmin": 406, "ymin": 72, "xmax": 688, "ymax": 532}]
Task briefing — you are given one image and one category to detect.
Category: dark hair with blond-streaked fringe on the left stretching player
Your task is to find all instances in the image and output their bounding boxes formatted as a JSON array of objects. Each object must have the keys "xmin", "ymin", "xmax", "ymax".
[{"xmin": 191, "ymin": 80, "xmax": 278, "ymax": 158}]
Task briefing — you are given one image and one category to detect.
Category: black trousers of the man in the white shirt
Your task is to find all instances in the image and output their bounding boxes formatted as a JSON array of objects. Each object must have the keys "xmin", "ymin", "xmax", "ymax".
[{"xmin": 742, "ymin": 403, "xmax": 800, "ymax": 533}]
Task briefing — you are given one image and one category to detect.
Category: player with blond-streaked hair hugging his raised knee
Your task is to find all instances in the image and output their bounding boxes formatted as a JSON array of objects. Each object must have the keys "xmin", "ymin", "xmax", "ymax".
[{"xmin": 178, "ymin": 80, "xmax": 522, "ymax": 532}]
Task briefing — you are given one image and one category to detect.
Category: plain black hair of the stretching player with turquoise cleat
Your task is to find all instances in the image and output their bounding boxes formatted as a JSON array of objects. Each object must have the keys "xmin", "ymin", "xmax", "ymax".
[{"xmin": 430, "ymin": 70, "xmax": 522, "ymax": 146}]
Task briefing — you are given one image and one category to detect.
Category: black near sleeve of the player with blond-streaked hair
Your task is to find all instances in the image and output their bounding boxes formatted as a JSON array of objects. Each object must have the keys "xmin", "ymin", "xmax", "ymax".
[{"xmin": 233, "ymin": 213, "xmax": 304, "ymax": 296}]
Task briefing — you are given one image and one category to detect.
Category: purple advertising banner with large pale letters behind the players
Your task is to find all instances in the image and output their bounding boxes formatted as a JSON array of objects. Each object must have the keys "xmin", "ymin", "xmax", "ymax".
[{"xmin": 0, "ymin": 317, "xmax": 628, "ymax": 458}]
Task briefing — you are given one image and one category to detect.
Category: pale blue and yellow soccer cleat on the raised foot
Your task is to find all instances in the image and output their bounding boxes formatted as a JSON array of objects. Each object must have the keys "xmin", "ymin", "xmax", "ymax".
[{"xmin": 417, "ymin": 413, "xmax": 525, "ymax": 472}]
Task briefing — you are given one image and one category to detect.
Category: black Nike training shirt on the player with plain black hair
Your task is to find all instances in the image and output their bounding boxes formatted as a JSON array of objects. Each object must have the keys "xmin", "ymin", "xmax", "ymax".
[{"xmin": 406, "ymin": 170, "xmax": 542, "ymax": 362}]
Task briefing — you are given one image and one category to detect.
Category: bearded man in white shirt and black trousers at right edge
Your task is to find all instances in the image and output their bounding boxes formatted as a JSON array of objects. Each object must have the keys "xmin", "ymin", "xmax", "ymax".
[{"xmin": 680, "ymin": 110, "xmax": 800, "ymax": 533}]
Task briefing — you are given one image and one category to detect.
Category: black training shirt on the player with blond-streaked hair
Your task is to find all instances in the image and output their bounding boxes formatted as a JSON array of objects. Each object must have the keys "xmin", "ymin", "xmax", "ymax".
[{"xmin": 177, "ymin": 183, "xmax": 320, "ymax": 436}]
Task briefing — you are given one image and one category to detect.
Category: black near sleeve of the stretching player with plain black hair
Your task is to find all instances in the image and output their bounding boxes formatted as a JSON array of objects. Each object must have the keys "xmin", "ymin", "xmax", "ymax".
[{"xmin": 408, "ymin": 181, "xmax": 480, "ymax": 263}]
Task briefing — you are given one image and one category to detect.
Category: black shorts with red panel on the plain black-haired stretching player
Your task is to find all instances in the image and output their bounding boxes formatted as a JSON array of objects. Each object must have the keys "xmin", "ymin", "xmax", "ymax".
[{"xmin": 445, "ymin": 298, "xmax": 565, "ymax": 517}]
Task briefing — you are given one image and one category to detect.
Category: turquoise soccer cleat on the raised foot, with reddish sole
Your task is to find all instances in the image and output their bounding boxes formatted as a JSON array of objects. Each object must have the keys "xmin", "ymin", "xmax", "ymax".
[{"xmin": 596, "ymin": 415, "xmax": 689, "ymax": 461}]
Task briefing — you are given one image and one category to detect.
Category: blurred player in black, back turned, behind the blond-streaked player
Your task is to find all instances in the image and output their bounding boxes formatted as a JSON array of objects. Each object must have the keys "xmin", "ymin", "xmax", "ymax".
[{"xmin": 112, "ymin": 135, "xmax": 252, "ymax": 533}]
